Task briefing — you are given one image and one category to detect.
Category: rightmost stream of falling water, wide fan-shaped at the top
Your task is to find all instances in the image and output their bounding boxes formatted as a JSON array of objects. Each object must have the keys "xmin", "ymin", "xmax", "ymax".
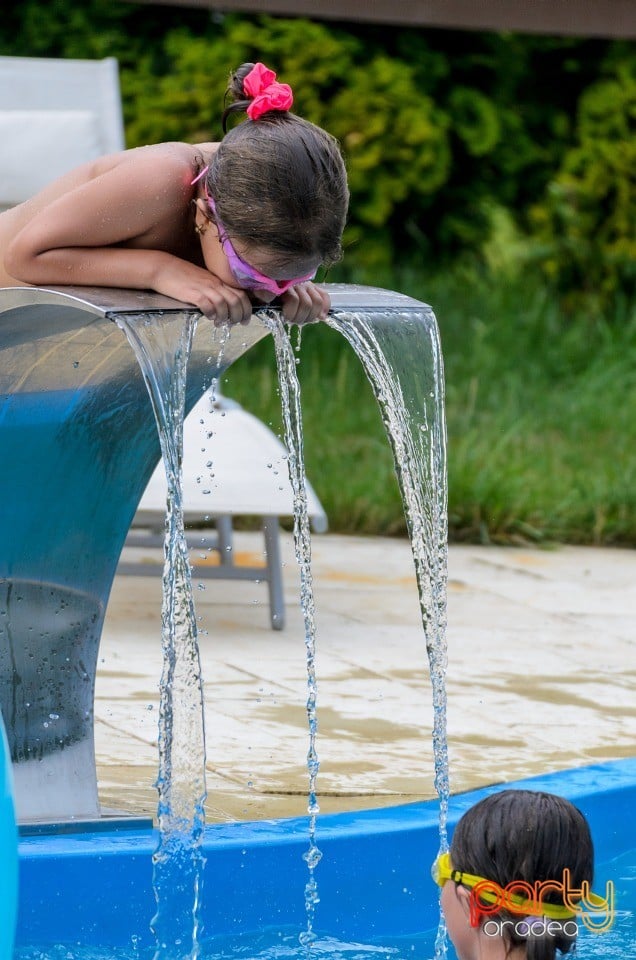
[{"xmin": 328, "ymin": 304, "xmax": 450, "ymax": 958}]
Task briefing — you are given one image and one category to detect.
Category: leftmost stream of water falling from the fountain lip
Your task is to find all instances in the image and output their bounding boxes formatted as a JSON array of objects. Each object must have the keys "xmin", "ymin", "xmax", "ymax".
[{"xmin": 120, "ymin": 312, "xmax": 206, "ymax": 960}]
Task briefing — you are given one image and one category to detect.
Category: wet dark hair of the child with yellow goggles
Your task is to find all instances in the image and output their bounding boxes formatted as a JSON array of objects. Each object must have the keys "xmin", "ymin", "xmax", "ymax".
[{"xmin": 450, "ymin": 790, "xmax": 594, "ymax": 960}]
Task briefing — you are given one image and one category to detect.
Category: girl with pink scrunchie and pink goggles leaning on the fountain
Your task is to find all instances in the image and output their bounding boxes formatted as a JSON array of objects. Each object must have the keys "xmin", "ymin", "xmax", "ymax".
[{"xmin": 0, "ymin": 63, "xmax": 349, "ymax": 324}]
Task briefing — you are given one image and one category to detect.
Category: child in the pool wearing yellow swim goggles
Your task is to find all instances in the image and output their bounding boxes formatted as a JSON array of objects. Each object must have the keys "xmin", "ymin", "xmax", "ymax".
[{"xmin": 433, "ymin": 790, "xmax": 610, "ymax": 960}]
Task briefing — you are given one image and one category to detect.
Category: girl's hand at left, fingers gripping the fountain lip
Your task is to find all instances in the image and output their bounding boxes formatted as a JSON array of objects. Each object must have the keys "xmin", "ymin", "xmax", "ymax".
[{"xmin": 153, "ymin": 260, "xmax": 253, "ymax": 327}]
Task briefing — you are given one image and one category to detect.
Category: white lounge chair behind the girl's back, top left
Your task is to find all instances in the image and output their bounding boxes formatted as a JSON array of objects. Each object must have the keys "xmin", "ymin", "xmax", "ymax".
[{"xmin": 0, "ymin": 57, "xmax": 124, "ymax": 209}]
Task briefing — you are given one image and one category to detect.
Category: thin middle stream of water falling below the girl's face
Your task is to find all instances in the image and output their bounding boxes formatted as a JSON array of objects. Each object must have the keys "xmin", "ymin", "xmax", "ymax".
[{"xmin": 262, "ymin": 311, "xmax": 322, "ymax": 956}]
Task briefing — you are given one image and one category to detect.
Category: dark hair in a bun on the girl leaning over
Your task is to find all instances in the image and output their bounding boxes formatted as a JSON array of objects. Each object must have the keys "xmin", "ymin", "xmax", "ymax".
[{"xmin": 207, "ymin": 63, "xmax": 349, "ymax": 266}]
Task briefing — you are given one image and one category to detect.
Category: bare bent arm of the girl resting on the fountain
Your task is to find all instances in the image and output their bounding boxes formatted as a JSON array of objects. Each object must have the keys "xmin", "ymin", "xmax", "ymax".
[{"xmin": 5, "ymin": 152, "xmax": 252, "ymax": 323}]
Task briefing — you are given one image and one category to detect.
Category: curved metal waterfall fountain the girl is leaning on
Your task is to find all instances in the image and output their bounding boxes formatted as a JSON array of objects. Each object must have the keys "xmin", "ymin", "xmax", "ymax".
[{"xmin": 0, "ymin": 286, "xmax": 448, "ymax": 821}]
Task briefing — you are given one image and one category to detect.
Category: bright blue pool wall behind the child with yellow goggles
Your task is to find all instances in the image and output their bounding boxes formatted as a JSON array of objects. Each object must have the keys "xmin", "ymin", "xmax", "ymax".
[{"xmin": 17, "ymin": 759, "xmax": 636, "ymax": 947}]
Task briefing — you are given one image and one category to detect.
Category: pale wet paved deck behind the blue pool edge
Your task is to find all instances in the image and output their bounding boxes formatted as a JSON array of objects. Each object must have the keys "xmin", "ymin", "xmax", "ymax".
[{"xmin": 96, "ymin": 533, "xmax": 636, "ymax": 821}]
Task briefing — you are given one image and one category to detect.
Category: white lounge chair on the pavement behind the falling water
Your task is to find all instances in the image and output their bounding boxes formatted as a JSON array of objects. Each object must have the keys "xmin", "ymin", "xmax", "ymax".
[{"xmin": 118, "ymin": 392, "xmax": 327, "ymax": 630}]
